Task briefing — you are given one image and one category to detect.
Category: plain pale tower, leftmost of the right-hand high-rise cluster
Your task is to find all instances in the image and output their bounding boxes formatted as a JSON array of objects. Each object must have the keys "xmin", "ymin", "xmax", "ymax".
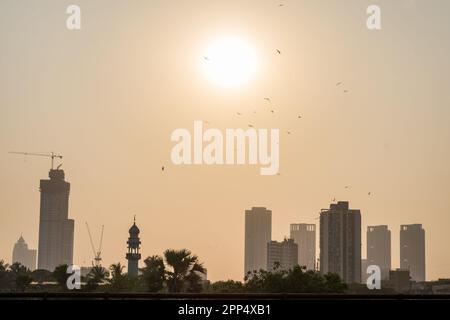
[{"xmin": 244, "ymin": 207, "xmax": 272, "ymax": 275}]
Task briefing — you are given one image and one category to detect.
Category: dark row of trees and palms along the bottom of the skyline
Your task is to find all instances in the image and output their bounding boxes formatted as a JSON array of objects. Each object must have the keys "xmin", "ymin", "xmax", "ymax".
[{"xmin": 0, "ymin": 249, "xmax": 348, "ymax": 293}]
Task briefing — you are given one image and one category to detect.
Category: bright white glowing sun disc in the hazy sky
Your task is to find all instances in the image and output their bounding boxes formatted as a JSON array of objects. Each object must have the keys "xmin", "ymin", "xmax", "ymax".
[{"xmin": 203, "ymin": 38, "xmax": 257, "ymax": 87}]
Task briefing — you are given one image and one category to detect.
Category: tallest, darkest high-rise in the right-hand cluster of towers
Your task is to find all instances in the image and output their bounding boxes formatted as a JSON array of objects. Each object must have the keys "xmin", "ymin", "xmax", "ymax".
[{"xmin": 320, "ymin": 201, "xmax": 361, "ymax": 283}]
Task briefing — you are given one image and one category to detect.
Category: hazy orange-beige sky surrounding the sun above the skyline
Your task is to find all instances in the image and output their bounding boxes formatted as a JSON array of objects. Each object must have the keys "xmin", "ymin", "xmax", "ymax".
[{"xmin": 0, "ymin": 0, "xmax": 450, "ymax": 280}]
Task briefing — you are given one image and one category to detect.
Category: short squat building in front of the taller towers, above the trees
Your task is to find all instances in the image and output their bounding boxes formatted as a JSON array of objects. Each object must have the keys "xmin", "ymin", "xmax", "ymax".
[{"xmin": 267, "ymin": 239, "xmax": 298, "ymax": 271}]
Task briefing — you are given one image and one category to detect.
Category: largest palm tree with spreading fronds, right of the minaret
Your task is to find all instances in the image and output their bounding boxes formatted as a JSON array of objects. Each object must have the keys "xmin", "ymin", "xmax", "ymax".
[{"xmin": 164, "ymin": 249, "xmax": 206, "ymax": 292}]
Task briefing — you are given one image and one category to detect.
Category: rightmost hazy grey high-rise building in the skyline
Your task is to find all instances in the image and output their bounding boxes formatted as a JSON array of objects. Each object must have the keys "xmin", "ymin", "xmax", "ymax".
[{"xmin": 400, "ymin": 224, "xmax": 426, "ymax": 281}]
